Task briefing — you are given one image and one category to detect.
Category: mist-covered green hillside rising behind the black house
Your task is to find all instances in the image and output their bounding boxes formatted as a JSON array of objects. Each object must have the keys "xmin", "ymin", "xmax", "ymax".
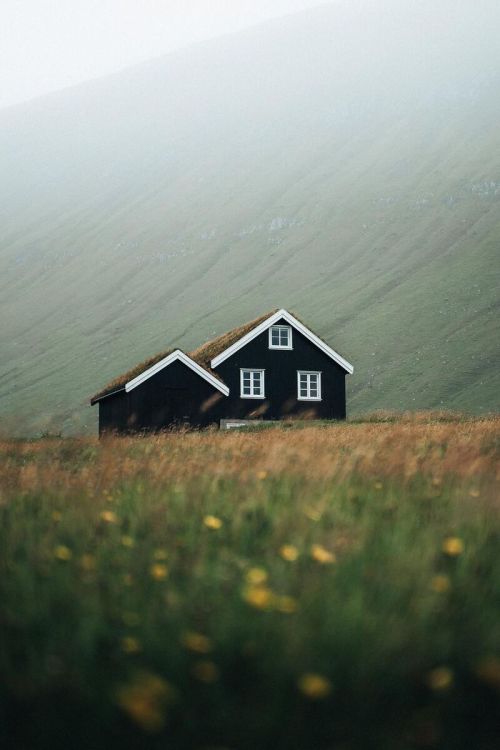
[{"xmin": 0, "ymin": 0, "xmax": 500, "ymax": 433}]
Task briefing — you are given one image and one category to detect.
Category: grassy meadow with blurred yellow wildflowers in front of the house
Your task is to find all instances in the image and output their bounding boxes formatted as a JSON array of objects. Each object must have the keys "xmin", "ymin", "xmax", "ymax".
[{"xmin": 0, "ymin": 416, "xmax": 500, "ymax": 750}]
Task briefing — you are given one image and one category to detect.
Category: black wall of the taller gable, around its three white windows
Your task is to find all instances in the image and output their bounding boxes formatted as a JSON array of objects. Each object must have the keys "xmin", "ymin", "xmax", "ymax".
[{"xmin": 216, "ymin": 320, "xmax": 346, "ymax": 419}]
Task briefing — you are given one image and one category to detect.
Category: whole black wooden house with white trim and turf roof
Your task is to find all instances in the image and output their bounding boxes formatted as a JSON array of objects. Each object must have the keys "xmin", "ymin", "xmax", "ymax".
[{"xmin": 91, "ymin": 310, "xmax": 353, "ymax": 434}]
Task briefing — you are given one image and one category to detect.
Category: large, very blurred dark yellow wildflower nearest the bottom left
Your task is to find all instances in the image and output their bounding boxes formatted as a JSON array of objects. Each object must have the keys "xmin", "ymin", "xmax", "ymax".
[{"xmin": 115, "ymin": 672, "xmax": 173, "ymax": 733}]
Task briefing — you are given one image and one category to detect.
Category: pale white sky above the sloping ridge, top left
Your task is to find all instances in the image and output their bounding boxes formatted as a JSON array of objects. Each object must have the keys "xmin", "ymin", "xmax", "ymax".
[{"xmin": 0, "ymin": 0, "xmax": 335, "ymax": 107}]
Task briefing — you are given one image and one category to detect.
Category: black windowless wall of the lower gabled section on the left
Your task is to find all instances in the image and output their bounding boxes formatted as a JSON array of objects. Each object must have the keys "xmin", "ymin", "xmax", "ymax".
[{"xmin": 99, "ymin": 361, "xmax": 225, "ymax": 434}]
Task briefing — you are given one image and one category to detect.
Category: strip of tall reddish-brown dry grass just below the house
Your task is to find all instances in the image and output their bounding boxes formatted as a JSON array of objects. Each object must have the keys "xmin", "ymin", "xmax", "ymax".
[{"xmin": 0, "ymin": 418, "xmax": 500, "ymax": 502}]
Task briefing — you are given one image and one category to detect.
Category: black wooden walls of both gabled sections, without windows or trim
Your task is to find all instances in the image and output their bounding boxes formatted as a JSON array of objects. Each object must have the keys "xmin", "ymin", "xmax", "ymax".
[{"xmin": 99, "ymin": 321, "xmax": 346, "ymax": 434}]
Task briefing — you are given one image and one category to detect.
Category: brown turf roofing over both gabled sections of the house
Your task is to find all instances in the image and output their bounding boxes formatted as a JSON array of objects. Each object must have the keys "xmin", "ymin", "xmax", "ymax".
[{"xmin": 90, "ymin": 310, "xmax": 277, "ymax": 404}]
